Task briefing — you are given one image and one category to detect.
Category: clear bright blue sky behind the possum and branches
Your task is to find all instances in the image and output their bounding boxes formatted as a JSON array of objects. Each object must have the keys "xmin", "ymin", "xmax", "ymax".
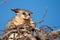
[{"xmin": 0, "ymin": 0, "xmax": 60, "ymax": 30}]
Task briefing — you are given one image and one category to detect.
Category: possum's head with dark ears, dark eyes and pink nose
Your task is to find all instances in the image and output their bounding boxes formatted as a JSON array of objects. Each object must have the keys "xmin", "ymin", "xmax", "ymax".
[{"xmin": 11, "ymin": 8, "xmax": 31, "ymax": 20}]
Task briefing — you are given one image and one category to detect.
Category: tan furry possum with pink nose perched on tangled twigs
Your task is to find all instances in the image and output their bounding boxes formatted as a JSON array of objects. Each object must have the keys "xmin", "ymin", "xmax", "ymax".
[{"xmin": 6, "ymin": 8, "xmax": 35, "ymax": 29}]
